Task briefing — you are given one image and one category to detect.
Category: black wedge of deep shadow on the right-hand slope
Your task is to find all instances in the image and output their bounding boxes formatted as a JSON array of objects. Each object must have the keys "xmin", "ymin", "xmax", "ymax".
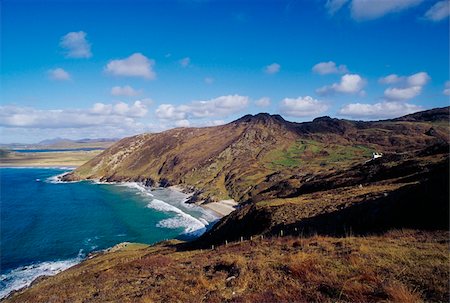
[{"xmin": 270, "ymin": 160, "xmax": 449, "ymax": 236}]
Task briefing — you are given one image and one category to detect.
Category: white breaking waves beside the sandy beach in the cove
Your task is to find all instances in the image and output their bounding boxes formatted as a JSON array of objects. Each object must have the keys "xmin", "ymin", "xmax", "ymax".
[{"xmin": 147, "ymin": 199, "xmax": 206, "ymax": 235}]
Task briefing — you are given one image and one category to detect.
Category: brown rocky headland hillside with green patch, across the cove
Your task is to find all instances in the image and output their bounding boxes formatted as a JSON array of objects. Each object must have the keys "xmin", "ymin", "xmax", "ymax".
[{"xmin": 64, "ymin": 108, "xmax": 448, "ymax": 202}]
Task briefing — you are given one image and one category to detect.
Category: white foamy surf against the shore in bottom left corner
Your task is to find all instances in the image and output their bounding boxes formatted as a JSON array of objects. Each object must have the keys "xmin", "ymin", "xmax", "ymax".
[{"xmin": 0, "ymin": 258, "xmax": 82, "ymax": 299}]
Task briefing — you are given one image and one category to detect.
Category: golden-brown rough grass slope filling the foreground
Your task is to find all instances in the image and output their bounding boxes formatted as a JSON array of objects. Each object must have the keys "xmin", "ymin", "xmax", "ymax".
[{"xmin": 6, "ymin": 230, "xmax": 449, "ymax": 302}]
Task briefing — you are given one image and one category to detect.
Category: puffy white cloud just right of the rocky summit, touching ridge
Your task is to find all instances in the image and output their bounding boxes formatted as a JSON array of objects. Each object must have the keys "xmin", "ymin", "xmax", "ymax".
[{"xmin": 280, "ymin": 96, "xmax": 328, "ymax": 117}]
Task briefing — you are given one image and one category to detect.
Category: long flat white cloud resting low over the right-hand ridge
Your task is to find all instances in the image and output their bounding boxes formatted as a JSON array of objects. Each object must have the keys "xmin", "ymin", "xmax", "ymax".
[{"xmin": 339, "ymin": 102, "xmax": 423, "ymax": 119}]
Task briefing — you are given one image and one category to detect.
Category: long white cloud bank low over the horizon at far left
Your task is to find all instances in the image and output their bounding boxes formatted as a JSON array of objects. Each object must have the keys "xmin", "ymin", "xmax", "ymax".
[{"xmin": 0, "ymin": 101, "xmax": 147, "ymax": 128}]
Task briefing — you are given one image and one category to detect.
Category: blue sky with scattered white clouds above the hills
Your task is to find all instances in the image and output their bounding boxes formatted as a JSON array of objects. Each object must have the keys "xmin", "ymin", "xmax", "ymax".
[{"xmin": 0, "ymin": 0, "xmax": 450, "ymax": 143}]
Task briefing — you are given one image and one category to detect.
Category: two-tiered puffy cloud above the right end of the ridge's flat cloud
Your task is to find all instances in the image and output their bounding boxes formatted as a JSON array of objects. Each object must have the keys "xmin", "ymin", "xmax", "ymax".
[{"xmin": 379, "ymin": 72, "xmax": 431, "ymax": 101}]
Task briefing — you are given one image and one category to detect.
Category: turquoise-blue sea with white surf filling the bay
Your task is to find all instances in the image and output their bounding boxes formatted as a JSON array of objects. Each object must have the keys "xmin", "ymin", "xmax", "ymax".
[{"xmin": 0, "ymin": 168, "xmax": 217, "ymax": 298}]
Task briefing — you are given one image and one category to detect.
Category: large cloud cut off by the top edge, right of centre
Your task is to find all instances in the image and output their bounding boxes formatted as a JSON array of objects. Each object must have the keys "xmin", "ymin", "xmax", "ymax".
[{"xmin": 351, "ymin": 0, "xmax": 423, "ymax": 21}]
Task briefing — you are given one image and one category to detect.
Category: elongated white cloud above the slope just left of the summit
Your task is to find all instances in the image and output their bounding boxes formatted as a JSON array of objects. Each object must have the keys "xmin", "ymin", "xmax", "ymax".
[{"xmin": 155, "ymin": 95, "xmax": 249, "ymax": 120}]
